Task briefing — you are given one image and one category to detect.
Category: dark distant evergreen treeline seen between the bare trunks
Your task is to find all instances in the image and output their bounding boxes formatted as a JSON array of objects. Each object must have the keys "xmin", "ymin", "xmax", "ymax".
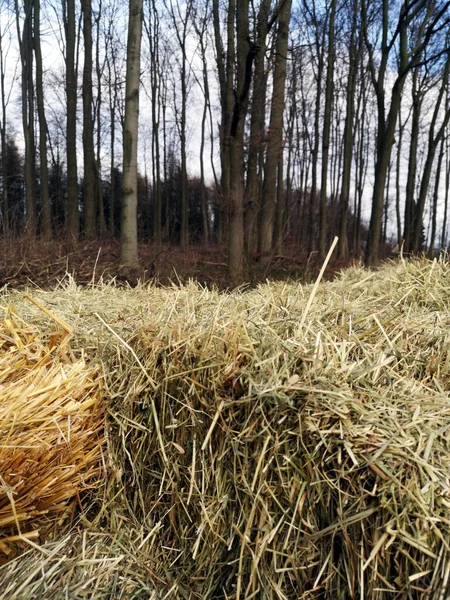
[{"xmin": 0, "ymin": 138, "xmax": 367, "ymax": 248}]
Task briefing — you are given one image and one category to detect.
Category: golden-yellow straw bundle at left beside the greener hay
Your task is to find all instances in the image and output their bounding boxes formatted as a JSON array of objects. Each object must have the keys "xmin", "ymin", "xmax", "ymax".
[{"xmin": 0, "ymin": 300, "xmax": 104, "ymax": 560}]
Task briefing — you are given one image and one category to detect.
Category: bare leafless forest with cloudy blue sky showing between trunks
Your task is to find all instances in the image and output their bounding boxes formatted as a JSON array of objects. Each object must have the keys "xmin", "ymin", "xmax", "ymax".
[{"xmin": 0, "ymin": 0, "xmax": 450, "ymax": 284}]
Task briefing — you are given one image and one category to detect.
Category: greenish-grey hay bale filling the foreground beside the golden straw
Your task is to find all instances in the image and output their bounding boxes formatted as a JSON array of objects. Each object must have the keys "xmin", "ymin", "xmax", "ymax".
[{"xmin": 0, "ymin": 260, "xmax": 450, "ymax": 600}]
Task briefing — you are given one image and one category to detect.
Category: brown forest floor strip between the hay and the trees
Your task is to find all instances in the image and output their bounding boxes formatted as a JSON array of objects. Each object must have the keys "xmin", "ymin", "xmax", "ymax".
[{"xmin": 0, "ymin": 239, "xmax": 358, "ymax": 290}]
